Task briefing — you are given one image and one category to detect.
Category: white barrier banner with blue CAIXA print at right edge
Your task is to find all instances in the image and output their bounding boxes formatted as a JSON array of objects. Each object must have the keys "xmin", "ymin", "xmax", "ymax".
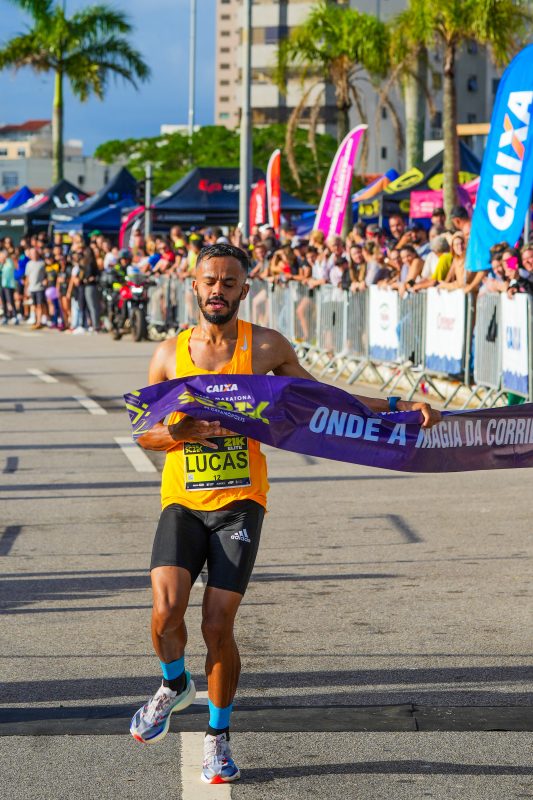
[{"xmin": 500, "ymin": 294, "xmax": 530, "ymax": 397}]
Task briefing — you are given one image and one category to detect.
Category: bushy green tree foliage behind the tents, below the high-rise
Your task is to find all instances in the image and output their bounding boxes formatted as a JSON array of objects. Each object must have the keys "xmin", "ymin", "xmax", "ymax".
[{"xmin": 95, "ymin": 124, "xmax": 337, "ymax": 204}]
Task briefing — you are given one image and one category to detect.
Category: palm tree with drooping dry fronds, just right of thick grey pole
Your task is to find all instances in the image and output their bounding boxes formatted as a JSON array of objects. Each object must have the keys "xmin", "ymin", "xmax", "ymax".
[{"xmin": 274, "ymin": 0, "xmax": 394, "ymax": 184}]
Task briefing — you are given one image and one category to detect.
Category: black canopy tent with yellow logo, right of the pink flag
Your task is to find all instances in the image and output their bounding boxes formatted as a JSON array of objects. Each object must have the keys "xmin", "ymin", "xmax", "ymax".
[{"xmin": 381, "ymin": 140, "xmax": 481, "ymax": 217}]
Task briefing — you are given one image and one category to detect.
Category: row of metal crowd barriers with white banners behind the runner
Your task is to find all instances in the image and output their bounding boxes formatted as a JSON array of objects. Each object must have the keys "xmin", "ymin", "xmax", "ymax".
[{"xmin": 168, "ymin": 276, "xmax": 533, "ymax": 407}]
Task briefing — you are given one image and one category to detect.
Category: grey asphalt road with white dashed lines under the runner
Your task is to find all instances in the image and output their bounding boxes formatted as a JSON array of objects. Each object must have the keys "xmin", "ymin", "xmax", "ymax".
[{"xmin": 0, "ymin": 329, "xmax": 533, "ymax": 800}]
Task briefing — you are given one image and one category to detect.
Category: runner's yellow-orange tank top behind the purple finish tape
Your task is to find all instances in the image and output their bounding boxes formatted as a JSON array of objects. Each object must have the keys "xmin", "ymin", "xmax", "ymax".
[{"xmin": 161, "ymin": 320, "xmax": 269, "ymax": 511}]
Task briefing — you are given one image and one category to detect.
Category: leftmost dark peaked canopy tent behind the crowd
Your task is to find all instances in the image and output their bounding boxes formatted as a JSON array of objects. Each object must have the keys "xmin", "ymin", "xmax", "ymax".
[{"xmin": 0, "ymin": 179, "xmax": 87, "ymax": 239}]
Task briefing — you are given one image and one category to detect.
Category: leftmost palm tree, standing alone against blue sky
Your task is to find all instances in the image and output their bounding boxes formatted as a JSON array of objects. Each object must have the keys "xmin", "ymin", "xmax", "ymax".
[{"xmin": 0, "ymin": 0, "xmax": 150, "ymax": 182}]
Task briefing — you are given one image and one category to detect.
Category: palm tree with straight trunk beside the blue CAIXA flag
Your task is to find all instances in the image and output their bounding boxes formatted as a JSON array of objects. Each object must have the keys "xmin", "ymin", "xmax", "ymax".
[{"xmin": 401, "ymin": 0, "xmax": 533, "ymax": 213}]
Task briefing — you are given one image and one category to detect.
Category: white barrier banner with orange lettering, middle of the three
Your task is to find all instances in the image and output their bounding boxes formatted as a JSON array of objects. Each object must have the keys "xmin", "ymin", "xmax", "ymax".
[{"xmin": 425, "ymin": 289, "xmax": 466, "ymax": 375}]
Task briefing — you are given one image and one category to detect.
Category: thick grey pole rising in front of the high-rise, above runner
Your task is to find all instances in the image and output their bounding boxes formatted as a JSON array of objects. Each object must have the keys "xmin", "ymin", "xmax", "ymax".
[{"xmin": 239, "ymin": 0, "xmax": 252, "ymax": 239}]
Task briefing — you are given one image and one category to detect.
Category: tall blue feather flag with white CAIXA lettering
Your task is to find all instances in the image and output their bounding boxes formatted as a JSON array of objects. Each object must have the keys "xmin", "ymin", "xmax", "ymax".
[{"xmin": 466, "ymin": 44, "xmax": 533, "ymax": 270}]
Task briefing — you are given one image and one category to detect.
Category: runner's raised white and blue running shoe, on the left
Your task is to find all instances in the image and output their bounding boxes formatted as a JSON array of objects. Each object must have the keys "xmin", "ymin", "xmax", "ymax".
[{"xmin": 130, "ymin": 672, "xmax": 196, "ymax": 744}]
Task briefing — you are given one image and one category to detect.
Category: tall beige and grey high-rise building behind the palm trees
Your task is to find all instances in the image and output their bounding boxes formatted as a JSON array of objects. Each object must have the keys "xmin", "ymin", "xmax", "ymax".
[{"xmin": 215, "ymin": 0, "xmax": 499, "ymax": 172}]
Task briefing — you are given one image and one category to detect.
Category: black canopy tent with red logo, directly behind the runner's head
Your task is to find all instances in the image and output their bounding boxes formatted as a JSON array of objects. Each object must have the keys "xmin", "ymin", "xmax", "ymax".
[{"xmin": 152, "ymin": 167, "xmax": 313, "ymax": 230}]
